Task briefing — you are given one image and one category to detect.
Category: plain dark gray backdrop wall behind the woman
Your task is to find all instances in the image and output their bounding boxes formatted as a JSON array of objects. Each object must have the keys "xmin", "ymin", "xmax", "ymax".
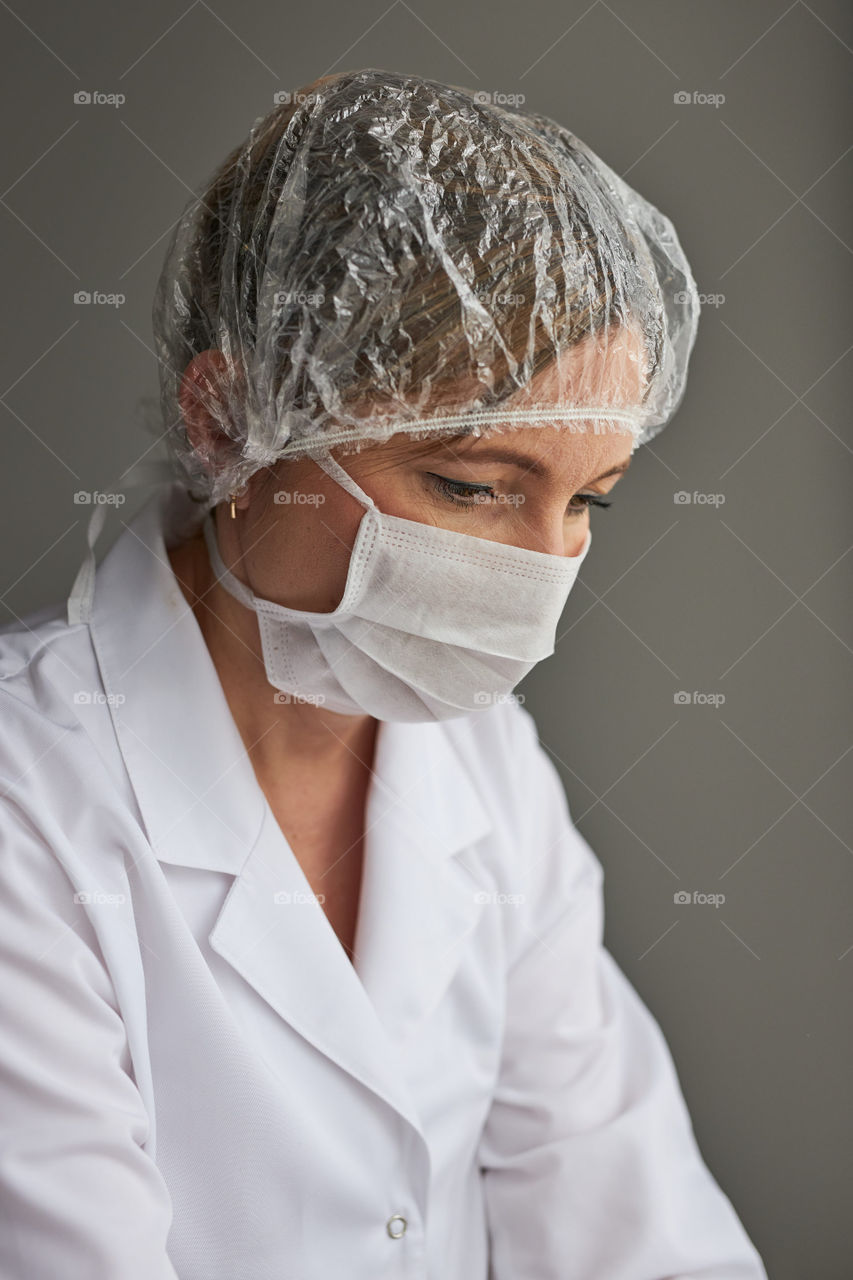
[{"xmin": 0, "ymin": 0, "xmax": 853, "ymax": 1280}]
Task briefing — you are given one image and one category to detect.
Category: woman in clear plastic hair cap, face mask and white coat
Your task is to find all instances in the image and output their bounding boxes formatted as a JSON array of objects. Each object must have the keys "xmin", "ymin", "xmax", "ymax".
[{"xmin": 0, "ymin": 69, "xmax": 765, "ymax": 1280}]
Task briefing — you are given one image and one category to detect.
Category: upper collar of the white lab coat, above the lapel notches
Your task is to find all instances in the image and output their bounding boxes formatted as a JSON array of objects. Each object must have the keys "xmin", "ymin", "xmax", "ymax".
[{"xmin": 90, "ymin": 481, "xmax": 491, "ymax": 874}]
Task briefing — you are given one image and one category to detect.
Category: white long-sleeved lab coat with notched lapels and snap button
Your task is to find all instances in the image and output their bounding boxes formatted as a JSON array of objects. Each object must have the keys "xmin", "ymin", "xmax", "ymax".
[{"xmin": 0, "ymin": 484, "xmax": 766, "ymax": 1280}]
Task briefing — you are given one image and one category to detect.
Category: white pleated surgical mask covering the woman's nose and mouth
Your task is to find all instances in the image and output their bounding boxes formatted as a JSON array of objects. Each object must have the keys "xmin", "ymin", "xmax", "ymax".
[{"xmin": 204, "ymin": 454, "xmax": 592, "ymax": 721}]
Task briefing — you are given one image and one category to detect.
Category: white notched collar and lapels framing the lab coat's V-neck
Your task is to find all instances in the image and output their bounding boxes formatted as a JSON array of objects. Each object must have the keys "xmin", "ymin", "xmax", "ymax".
[{"xmin": 84, "ymin": 490, "xmax": 492, "ymax": 1128}]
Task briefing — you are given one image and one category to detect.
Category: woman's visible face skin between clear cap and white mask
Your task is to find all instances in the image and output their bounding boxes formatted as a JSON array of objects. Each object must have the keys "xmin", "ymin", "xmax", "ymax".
[{"xmin": 218, "ymin": 325, "xmax": 642, "ymax": 612}]
